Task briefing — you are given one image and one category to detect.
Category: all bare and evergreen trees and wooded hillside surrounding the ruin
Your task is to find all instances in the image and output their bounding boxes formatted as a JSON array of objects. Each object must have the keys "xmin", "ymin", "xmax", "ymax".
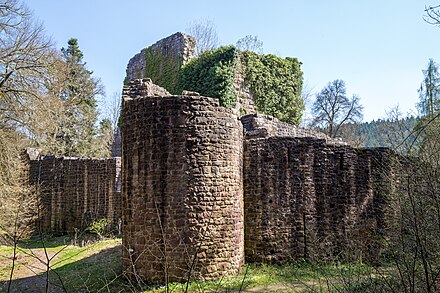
[{"xmin": 0, "ymin": 0, "xmax": 440, "ymax": 292}]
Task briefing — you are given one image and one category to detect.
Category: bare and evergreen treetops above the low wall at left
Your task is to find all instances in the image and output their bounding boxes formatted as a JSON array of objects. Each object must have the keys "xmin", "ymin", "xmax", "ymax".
[{"xmin": 0, "ymin": 0, "xmax": 111, "ymax": 156}]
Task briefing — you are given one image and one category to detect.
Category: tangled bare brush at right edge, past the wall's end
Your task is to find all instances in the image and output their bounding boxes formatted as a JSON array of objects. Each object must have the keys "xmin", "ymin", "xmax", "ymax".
[{"xmin": 389, "ymin": 114, "xmax": 440, "ymax": 292}]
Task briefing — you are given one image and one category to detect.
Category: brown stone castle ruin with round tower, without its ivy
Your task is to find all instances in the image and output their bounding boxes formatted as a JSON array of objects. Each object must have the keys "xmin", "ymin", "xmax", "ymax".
[{"xmin": 31, "ymin": 33, "xmax": 395, "ymax": 283}]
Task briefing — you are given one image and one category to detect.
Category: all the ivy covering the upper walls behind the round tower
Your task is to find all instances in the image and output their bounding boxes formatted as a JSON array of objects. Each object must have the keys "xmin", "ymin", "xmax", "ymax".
[{"xmin": 145, "ymin": 46, "xmax": 304, "ymax": 125}]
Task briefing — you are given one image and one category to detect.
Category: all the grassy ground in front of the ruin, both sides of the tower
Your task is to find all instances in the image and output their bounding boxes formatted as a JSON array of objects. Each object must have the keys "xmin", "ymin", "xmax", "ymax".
[{"xmin": 0, "ymin": 236, "xmax": 392, "ymax": 293}]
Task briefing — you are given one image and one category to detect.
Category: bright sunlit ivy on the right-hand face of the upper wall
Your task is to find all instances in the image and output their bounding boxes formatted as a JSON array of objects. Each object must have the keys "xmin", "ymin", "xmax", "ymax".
[{"xmin": 241, "ymin": 51, "xmax": 304, "ymax": 125}]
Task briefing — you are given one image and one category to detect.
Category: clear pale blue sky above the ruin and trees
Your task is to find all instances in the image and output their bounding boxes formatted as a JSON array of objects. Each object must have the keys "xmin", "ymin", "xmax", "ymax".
[{"xmin": 25, "ymin": 0, "xmax": 440, "ymax": 121}]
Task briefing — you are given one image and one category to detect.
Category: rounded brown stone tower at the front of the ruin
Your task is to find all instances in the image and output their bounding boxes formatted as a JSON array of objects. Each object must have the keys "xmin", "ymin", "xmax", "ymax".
[{"xmin": 122, "ymin": 80, "xmax": 244, "ymax": 283}]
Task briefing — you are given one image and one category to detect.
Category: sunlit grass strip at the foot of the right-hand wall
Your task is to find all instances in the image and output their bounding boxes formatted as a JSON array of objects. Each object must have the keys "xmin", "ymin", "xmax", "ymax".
[{"xmin": 137, "ymin": 261, "xmax": 384, "ymax": 293}]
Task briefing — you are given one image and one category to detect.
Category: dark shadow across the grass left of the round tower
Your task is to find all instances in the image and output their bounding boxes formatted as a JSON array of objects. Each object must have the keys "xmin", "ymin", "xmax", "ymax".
[{"xmin": 0, "ymin": 245, "xmax": 131, "ymax": 292}]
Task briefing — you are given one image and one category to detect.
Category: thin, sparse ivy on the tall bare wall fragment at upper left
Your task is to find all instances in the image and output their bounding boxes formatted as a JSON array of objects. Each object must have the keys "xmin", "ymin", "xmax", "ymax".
[{"xmin": 145, "ymin": 47, "xmax": 183, "ymax": 95}]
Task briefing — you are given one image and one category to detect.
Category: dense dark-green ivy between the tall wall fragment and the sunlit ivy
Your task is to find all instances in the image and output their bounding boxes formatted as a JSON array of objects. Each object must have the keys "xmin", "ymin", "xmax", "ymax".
[{"xmin": 180, "ymin": 46, "xmax": 238, "ymax": 107}]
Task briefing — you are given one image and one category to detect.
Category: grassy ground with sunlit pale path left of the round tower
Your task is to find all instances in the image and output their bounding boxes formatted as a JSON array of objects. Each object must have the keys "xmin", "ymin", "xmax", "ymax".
[{"xmin": 0, "ymin": 235, "xmax": 123, "ymax": 292}]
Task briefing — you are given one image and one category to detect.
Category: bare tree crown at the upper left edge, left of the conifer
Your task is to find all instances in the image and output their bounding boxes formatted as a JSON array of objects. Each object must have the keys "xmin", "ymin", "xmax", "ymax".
[{"xmin": 0, "ymin": 0, "xmax": 53, "ymax": 127}]
